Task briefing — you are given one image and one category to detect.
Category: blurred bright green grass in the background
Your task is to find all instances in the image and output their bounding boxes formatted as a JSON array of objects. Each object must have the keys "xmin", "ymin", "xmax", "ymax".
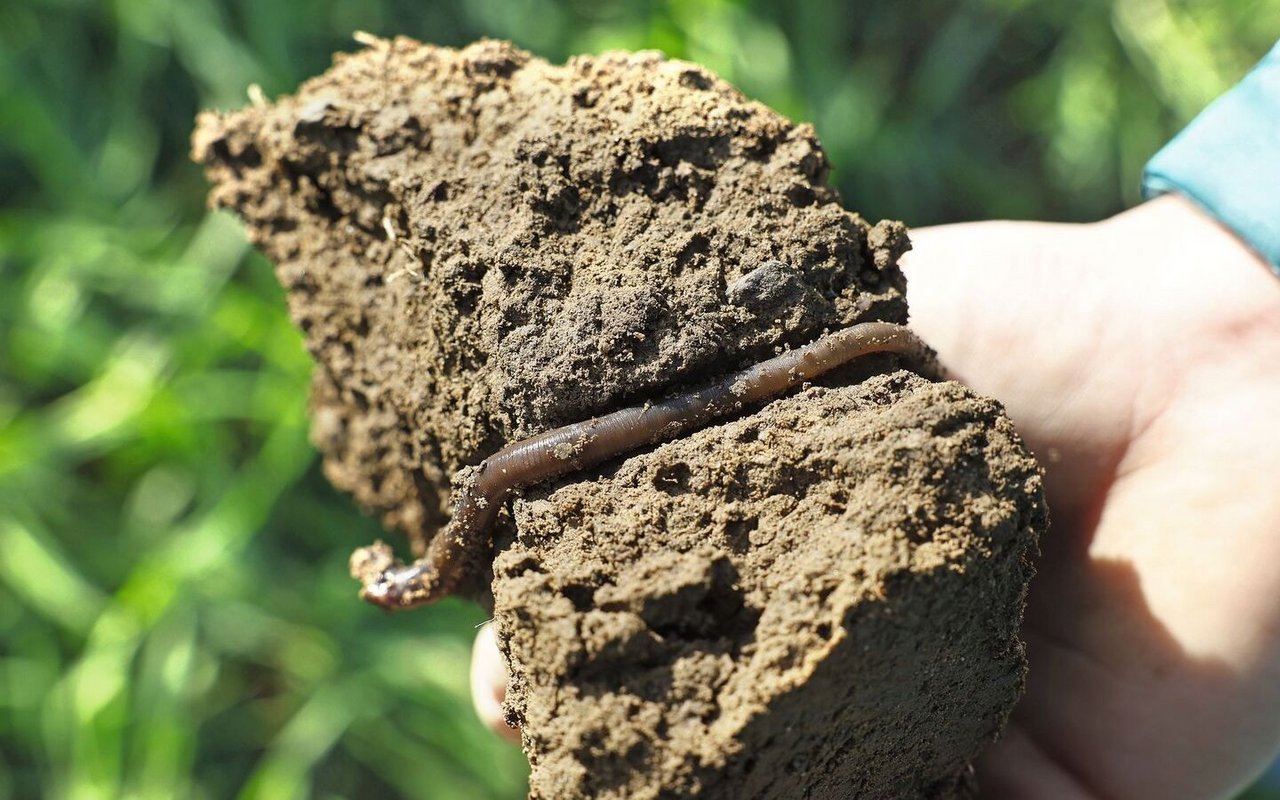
[{"xmin": 0, "ymin": 0, "xmax": 1280, "ymax": 800}]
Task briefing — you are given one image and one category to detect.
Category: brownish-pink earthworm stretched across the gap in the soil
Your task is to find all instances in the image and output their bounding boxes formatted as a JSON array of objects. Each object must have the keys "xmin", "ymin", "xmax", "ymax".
[{"xmin": 352, "ymin": 323, "xmax": 936, "ymax": 608}]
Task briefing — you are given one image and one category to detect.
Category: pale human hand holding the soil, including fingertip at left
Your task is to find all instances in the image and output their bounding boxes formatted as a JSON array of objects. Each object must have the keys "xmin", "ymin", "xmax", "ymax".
[{"xmin": 472, "ymin": 197, "xmax": 1280, "ymax": 800}]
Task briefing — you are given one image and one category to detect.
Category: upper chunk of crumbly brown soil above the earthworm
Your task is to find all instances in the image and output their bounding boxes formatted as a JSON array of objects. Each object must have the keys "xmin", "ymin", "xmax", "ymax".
[{"xmin": 193, "ymin": 40, "xmax": 906, "ymax": 555}]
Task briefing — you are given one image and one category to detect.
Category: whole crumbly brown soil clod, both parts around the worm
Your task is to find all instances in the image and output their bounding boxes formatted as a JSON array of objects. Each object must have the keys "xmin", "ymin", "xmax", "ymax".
[{"xmin": 193, "ymin": 38, "xmax": 1046, "ymax": 799}]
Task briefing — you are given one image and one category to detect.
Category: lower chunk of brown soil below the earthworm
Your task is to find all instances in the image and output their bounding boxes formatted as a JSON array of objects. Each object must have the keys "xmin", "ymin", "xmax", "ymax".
[{"xmin": 494, "ymin": 372, "xmax": 1046, "ymax": 799}]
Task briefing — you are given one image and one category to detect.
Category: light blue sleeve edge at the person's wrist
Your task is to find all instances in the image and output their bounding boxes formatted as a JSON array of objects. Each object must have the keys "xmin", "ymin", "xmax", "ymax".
[{"xmin": 1142, "ymin": 44, "xmax": 1280, "ymax": 274}]
